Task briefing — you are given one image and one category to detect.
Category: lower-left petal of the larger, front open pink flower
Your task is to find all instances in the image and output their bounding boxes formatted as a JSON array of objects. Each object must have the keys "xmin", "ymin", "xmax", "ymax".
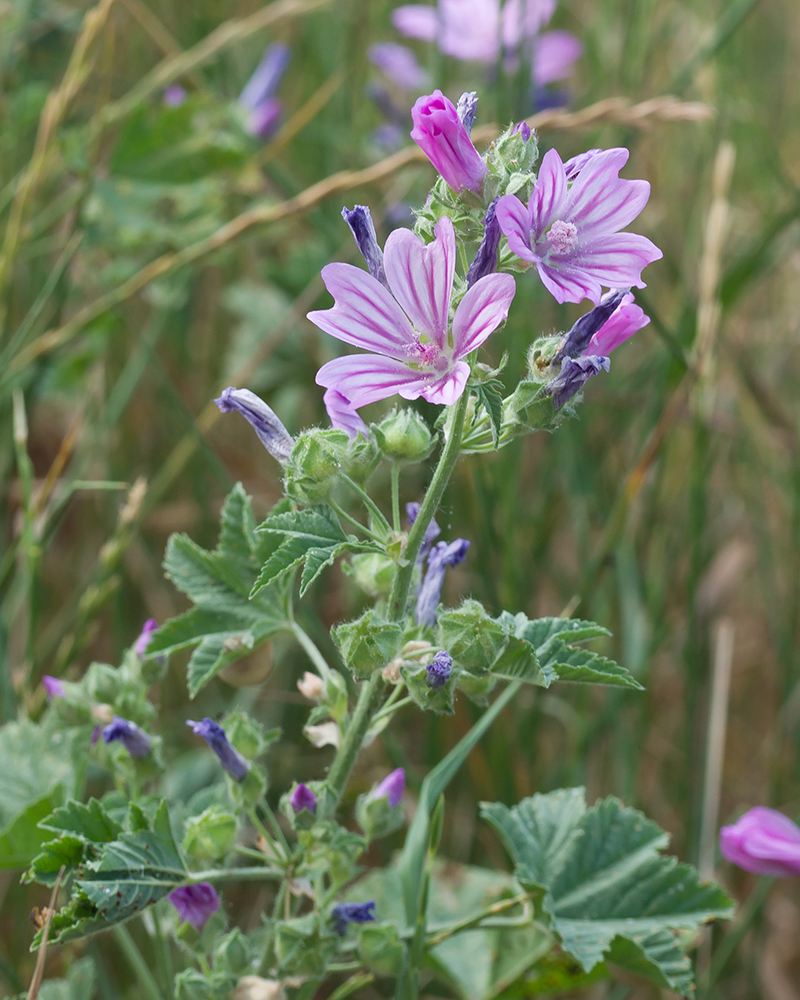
[{"xmin": 316, "ymin": 354, "xmax": 433, "ymax": 410}]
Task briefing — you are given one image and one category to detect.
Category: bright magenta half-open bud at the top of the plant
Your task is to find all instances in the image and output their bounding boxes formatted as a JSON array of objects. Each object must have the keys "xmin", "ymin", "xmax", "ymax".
[{"xmin": 411, "ymin": 90, "xmax": 487, "ymax": 194}]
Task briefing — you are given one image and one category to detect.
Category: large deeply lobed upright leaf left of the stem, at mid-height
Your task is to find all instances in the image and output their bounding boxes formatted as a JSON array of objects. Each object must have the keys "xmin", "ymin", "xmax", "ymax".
[{"xmin": 155, "ymin": 483, "xmax": 286, "ymax": 698}]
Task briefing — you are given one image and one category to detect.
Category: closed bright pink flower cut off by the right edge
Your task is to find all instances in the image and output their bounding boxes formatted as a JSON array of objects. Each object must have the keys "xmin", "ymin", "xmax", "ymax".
[{"xmin": 719, "ymin": 806, "xmax": 800, "ymax": 877}]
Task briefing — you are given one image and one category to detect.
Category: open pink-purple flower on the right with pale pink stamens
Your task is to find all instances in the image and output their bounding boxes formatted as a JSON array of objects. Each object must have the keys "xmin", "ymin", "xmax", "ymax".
[{"xmin": 497, "ymin": 149, "xmax": 663, "ymax": 305}]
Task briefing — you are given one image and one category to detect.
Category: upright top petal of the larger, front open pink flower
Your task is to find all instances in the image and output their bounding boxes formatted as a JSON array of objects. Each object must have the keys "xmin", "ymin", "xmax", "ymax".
[{"xmin": 383, "ymin": 216, "xmax": 456, "ymax": 347}]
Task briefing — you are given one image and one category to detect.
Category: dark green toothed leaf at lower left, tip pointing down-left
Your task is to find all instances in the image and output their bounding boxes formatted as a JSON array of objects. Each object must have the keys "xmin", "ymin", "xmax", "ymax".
[{"xmin": 43, "ymin": 800, "xmax": 187, "ymax": 944}]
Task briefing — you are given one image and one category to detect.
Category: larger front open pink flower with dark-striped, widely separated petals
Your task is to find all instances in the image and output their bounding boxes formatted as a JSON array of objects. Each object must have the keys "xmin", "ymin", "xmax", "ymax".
[{"xmin": 308, "ymin": 217, "xmax": 515, "ymax": 418}]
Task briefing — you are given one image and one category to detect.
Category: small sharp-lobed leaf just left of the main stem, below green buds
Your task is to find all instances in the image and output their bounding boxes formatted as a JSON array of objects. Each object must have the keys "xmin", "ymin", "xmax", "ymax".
[{"xmin": 251, "ymin": 504, "xmax": 376, "ymax": 597}]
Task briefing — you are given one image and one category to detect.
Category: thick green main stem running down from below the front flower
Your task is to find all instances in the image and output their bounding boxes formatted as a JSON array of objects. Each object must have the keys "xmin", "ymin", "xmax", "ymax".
[{"xmin": 328, "ymin": 392, "xmax": 469, "ymax": 812}]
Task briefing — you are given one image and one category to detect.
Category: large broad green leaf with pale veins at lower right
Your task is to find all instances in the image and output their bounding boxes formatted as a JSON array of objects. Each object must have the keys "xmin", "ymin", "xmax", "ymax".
[{"xmin": 481, "ymin": 789, "xmax": 733, "ymax": 995}]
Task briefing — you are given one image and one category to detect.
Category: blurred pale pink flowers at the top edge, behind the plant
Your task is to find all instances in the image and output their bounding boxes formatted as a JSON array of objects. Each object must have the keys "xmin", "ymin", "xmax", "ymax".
[{"xmin": 392, "ymin": 0, "xmax": 583, "ymax": 86}]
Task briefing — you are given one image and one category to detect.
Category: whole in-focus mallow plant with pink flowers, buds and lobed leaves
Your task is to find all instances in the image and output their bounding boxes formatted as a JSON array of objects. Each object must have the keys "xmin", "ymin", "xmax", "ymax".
[{"xmin": 25, "ymin": 91, "xmax": 736, "ymax": 1000}]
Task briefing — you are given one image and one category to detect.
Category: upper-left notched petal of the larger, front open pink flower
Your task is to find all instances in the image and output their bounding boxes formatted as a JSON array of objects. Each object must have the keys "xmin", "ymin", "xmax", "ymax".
[{"xmin": 308, "ymin": 264, "xmax": 414, "ymax": 358}]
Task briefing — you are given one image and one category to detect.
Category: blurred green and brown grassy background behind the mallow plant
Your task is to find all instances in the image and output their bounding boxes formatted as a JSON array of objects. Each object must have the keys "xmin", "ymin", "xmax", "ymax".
[{"xmin": 0, "ymin": 0, "xmax": 800, "ymax": 1000}]
